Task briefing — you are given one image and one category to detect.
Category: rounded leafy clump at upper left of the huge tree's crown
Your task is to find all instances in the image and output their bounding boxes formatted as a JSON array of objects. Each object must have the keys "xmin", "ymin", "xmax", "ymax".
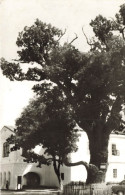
[{"xmin": 16, "ymin": 19, "xmax": 62, "ymax": 64}]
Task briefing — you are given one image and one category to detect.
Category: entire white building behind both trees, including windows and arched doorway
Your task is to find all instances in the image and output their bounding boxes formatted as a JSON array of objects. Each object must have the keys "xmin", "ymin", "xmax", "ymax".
[{"xmin": 0, "ymin": 126, "xmax": 125, "ymax": 190}]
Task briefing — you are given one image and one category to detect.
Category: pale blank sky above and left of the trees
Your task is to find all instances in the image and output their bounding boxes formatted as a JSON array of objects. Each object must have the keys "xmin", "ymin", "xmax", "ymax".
[{"xmin": 0, "ymin": 0, "xmax": 125, "ymax": 128}]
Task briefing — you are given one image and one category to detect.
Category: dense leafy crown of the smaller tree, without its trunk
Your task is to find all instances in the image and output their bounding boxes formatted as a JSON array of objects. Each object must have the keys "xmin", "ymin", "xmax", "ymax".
[{"xmin": 15, "ymin": 84, "xmax": 79, "ymax": 163}]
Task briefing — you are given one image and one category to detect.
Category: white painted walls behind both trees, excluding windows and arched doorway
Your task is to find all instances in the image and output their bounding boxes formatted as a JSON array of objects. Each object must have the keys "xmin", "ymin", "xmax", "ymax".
[{"xmin": 0, "ymin": 127, "xmax": 125, "ymax": 189}]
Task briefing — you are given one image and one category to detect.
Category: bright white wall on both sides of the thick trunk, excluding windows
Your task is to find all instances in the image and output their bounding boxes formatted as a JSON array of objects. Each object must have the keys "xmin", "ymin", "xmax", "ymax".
[{"xmin": 71, "ymin": 132, "xmax": 125, "ymax": 182}]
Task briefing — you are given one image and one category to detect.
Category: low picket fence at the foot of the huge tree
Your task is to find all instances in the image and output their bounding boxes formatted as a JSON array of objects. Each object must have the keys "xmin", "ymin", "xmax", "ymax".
[{"xmin": 63, "ymin": 182, "xmax": 111, "ymax": 195}]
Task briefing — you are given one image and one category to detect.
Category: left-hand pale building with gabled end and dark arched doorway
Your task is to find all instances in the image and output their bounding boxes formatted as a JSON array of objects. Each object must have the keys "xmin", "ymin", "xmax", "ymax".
[{"xmin": 0, "ymin": 126, "xmax": 71, "ymax": 190}]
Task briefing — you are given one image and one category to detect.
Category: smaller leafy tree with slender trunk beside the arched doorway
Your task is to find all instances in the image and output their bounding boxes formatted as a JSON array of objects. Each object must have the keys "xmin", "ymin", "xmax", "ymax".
[{"xmin": 7, "ymin": 89, "xmax": 80, "ymax": 184}]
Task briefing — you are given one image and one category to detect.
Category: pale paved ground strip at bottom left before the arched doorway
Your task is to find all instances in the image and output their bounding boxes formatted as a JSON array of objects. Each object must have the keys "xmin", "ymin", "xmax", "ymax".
[{"xmin": 0, "ymin": 189, "xmax": 62, "ymax": 195}]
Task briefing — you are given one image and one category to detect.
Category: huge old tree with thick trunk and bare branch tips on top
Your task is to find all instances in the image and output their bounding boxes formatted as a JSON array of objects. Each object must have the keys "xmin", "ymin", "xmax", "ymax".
[{"xmin": 1, "ymin": 5, "xmax": 125, "ymax": 182}]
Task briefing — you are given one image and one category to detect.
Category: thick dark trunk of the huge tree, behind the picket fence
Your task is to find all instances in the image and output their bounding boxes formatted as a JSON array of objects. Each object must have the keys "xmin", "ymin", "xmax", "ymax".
[{"xmin": 87, "ymin": 126, "xmax": 109, "ymax": 183}]
